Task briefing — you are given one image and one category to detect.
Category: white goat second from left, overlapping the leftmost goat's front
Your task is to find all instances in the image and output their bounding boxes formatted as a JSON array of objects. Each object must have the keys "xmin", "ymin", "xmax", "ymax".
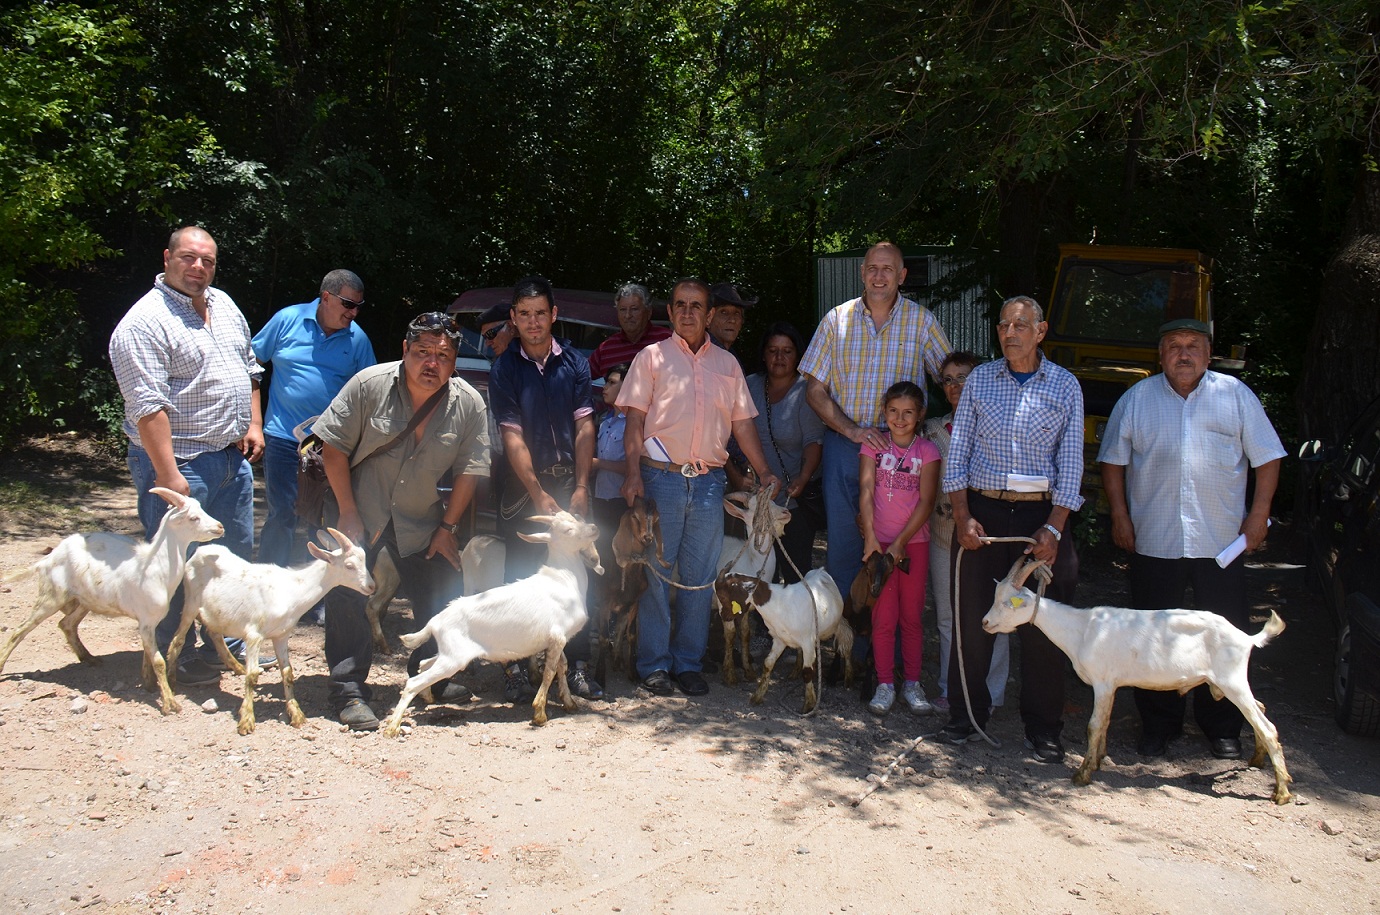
[{"xmin": 168, "ymin": 527, "xmax": 374, "ymax": 734}]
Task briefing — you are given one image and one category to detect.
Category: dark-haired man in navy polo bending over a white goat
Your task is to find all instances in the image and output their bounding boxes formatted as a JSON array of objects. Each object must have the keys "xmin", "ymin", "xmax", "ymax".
[{"xmin": 489, "ymin": 276, "xmax": 602, "ymax": 701}]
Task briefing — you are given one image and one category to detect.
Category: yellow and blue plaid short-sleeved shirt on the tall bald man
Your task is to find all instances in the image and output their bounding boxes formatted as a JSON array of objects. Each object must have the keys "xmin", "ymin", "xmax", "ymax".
[{"xmin": 800, "ymin": 295, "xmax": 951, "ymax": 426}]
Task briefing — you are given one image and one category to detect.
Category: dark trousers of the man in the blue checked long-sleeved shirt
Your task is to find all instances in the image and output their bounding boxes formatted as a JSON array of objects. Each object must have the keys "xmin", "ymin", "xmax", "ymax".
[{"xmin": 948, "ymin": 490, "xmax": 1078, "ymax": 737}]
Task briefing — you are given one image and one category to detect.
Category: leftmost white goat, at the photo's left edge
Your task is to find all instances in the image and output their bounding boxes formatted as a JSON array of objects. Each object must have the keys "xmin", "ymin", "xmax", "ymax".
[{"xmin": 0, "ymin": 486, "xmax": 225, "ymax": 715}]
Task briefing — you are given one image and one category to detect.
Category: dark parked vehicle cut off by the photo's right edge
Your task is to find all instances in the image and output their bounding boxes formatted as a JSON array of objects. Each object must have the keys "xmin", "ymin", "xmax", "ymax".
[{"xmin": 1299, "ymin": 399, "xmax": 1380, "ymax": 737}]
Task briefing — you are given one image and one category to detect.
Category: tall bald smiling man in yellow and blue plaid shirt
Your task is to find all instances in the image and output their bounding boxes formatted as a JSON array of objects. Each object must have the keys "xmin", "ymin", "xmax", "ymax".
[{"xmin": 800, "ymin": 242, "xmax": 949, "ymax": 607}]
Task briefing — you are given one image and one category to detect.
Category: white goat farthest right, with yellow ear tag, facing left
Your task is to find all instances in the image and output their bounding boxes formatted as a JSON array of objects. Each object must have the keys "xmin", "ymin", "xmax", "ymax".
[{"xmin": 983, "ymin": 558, "xmax": 1293, "ymax": 803}]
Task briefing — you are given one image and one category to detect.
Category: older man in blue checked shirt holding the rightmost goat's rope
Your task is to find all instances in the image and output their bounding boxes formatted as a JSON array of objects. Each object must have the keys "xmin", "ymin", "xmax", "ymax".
[{"xmin": 944, "ymin": 295, "xmax": 1083, "ymax": 762}]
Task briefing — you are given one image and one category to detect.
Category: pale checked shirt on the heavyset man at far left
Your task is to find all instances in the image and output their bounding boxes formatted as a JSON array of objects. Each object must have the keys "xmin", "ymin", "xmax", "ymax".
[{"xmin": 110, "ymin": 273, "xmax": 264, "ymax": 461}]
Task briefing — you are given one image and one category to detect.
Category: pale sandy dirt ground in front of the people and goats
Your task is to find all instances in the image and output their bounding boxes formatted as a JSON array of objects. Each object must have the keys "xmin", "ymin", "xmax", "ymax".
[{"xmin": 0, "ymin": 441, "xmax": 1380, "ymax": 915}]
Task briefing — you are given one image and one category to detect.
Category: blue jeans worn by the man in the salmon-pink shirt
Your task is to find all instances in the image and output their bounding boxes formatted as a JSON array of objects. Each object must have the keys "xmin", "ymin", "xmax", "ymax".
[{"xmin": 638, "ymin": 466, "xmax": 727, "ymax": 676}]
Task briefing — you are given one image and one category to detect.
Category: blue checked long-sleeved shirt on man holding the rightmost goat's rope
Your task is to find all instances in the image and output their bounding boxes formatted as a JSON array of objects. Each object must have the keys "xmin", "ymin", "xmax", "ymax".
[{"xmin": 943, "ymin": 353, "xmax": 1083, "ymax": 512}]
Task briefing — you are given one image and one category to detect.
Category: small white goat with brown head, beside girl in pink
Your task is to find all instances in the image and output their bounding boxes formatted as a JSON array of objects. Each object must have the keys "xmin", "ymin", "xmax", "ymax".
[{"xmin": 713, "ymin": 569, "xmax": 853, "ymax": 712}]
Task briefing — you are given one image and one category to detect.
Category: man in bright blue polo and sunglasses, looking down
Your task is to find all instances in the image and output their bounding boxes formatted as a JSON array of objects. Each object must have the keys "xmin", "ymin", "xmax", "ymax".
[{"xmin": 250, "ymin": 270, "xmax": 375, "ymax": 579}]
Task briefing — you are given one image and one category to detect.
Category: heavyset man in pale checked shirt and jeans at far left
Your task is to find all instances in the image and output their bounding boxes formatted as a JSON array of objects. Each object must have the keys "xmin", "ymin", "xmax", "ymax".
[{"xmin": 110, "ymin": 226, "xmax": 264, "ymax": 686}]
